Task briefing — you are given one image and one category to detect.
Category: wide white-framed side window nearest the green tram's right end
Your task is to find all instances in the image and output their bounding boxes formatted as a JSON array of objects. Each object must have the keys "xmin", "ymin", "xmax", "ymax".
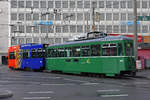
[{"xmin": 102, "ymin": 44, "xmax": 117, "ymax": 56}]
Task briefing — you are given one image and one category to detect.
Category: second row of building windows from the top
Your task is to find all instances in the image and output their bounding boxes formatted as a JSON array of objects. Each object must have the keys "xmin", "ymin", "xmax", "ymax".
[{"xmin": 11, "ymin": 13, "xmax": 148, "ymax": 21}]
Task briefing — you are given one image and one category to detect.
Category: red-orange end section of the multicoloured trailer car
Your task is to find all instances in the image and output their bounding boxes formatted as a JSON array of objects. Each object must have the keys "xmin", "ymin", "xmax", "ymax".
[{"xmin": 8, "ymin": 45, "xmax": 20, "ymax": 69}]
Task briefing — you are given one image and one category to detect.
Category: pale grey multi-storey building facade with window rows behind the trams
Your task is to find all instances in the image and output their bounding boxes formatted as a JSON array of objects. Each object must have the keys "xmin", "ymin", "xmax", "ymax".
[{"xmin": 9, "ymin": 0, "xmax": 150, "ymax": 46}]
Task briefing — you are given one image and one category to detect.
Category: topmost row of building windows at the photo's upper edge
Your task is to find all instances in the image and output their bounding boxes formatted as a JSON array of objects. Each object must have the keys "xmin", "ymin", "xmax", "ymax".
[{"xmin": 11, "ymin": 0, "xmax": 150, "ymax": 9}]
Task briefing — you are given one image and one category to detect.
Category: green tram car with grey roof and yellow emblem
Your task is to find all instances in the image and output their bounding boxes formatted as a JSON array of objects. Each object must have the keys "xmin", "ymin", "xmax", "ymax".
[{"xmin": 46, "ymin": 36, "xmax": 136, "ymax": 76}]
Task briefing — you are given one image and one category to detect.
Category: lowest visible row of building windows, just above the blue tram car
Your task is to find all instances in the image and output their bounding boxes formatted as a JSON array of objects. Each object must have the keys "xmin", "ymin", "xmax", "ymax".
[{"xmin": 11, "ymin": 37, "xmax": 68, "ymax": 45}]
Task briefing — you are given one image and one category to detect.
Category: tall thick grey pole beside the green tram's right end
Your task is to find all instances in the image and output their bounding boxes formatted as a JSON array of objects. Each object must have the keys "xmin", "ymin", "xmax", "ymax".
[{"xmin": 133, "ymin": 0, "xmax": 138, "ymax": 60}]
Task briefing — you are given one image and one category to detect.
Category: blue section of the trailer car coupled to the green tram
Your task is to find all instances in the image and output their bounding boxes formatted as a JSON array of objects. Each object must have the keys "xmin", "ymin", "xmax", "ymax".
[{"xmin": 20, "ymin": 43, "xmax": 48, "ymax": 70}]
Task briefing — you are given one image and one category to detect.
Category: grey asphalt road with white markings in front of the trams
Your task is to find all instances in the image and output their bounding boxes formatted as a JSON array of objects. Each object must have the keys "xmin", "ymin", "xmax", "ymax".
[{"xmin": 0, "ymin": 66, "xmax": 150, "ymax": 100}]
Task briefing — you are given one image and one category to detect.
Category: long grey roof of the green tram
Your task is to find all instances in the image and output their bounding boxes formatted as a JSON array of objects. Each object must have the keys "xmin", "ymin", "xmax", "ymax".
[{"xmin": 50, "ymin": 35, "xmax": 132, "ymax": 46}]
